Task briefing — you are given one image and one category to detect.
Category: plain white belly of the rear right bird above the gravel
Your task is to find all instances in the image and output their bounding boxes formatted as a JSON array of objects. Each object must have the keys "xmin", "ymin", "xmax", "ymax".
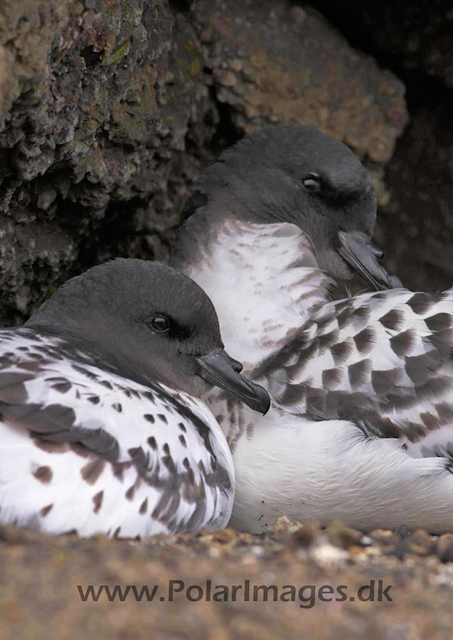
[{"xmin": 221, "ymin": 412, "xmax": 453, "ymax": 533}]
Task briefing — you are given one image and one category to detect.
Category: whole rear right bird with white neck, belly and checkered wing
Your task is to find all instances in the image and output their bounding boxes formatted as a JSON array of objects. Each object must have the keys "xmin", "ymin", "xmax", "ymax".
[{"xmin": 174, "ymin": 126, "xmax": 453, "ymax": 532}]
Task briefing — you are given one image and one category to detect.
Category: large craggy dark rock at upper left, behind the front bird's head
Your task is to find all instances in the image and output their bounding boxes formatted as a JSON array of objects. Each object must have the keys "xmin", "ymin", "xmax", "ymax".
[{"xmin": 0, "ymin": 0, "xmax": 213, "ymax": 318}]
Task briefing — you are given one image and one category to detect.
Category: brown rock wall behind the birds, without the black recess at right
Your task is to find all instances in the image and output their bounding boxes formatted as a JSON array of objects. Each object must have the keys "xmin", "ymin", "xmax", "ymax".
[{"xmin": 0, "ymin": 0, "xmax": 406, "ymax": 322}]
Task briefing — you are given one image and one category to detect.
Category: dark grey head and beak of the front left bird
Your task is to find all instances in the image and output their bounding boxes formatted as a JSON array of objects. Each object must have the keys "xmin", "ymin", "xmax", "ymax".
[{"xmin": 25, "ymin": 258, "xmax": 269, "ymax": 412}]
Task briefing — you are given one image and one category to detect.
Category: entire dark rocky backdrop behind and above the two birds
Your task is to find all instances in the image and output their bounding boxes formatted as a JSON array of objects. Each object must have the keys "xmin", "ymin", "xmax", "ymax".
[{"xmin": 0, "ymin": 0, "xmax": 453, "ymax": 323}]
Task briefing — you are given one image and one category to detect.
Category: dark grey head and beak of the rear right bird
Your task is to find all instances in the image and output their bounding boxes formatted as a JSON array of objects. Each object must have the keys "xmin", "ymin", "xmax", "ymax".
[{"xmin": 175, "ymin": 124, "xmax": 398, "ymax": 287}]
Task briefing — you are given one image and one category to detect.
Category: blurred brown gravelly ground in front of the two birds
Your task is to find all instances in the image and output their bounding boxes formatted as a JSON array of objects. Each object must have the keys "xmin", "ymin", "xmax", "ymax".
[{"xmin": 0, "ymin": 519, "xmax": 453, "ymax": 640}]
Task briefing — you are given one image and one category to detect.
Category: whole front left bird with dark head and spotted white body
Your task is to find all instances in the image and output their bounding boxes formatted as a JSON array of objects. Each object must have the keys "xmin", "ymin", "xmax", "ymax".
[{"xmin": 0, "ymin": 260, "xmax": 268, "ymax": 538}]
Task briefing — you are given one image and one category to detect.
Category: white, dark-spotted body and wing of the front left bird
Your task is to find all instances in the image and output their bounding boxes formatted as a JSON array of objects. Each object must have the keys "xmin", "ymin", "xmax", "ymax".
[{"xmin": 0, "ymin": 329, "xmax": 234, "ymax": 536}]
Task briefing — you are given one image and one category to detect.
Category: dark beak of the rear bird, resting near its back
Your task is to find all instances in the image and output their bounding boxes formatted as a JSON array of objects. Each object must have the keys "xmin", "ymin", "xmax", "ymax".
[{"xmin": 338, "ymin": 231, "xmax": 403, "ymax": 291}]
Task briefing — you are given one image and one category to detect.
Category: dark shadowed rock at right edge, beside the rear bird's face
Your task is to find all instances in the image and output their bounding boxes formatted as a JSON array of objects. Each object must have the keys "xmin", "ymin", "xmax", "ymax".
[{"xmin": 376, "ymin": 97, "xmax": 453, "ymax": 291}]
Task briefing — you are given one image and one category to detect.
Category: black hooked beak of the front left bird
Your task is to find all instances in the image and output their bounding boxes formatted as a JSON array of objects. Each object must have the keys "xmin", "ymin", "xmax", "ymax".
[{"xmin": 197, "ymin": 348, "xmax": 271, "ymax": 414}]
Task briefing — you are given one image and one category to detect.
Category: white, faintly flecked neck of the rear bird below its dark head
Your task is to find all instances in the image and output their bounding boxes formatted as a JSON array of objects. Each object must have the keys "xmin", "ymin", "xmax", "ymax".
[{"xmin": 172, "ymin": 216, "xmax": 332, "ymax": 372}]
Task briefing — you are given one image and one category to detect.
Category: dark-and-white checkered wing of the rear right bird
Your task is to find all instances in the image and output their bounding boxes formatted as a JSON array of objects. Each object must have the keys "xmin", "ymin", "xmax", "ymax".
[{"xmin": 259, "ymin": 289, "xmax": 453, "ymax": 456}]
